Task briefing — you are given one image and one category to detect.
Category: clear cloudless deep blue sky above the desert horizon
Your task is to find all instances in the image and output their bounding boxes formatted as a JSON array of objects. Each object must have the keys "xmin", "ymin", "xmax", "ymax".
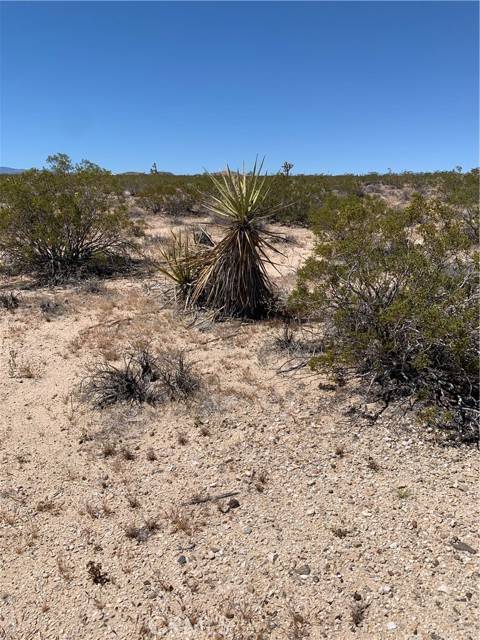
[{"xmin": 0, "ymin": 2, "xmax": 478, "ymax": 173}]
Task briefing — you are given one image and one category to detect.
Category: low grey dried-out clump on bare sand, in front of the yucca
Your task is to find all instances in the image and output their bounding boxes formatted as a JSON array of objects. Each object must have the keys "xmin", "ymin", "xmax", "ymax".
[{"xmin": 82, "ymin": 347, "xmax": 200, "ymax": 409}]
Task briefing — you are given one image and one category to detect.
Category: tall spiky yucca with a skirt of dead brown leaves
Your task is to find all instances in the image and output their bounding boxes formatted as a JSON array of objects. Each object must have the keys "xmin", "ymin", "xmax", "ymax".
[{"xmin": 191, "ymin": 161, "xmax": 278, "ymax": 318}]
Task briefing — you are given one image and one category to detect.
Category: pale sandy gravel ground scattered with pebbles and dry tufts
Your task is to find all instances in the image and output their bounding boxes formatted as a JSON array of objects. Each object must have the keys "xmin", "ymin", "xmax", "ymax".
[{"xmin": 0, "ymin": 211, "xmax": 480, "ymax": 640}]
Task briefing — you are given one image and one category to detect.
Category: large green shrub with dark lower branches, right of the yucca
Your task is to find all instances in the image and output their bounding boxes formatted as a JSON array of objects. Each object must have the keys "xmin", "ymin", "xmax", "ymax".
[{"xmin": 291, "ymin": 196, "xmax": 479, "ymax": 440}]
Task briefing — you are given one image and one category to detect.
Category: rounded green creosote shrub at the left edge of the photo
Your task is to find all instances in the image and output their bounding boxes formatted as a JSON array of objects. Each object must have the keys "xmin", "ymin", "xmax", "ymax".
[{"xmin": 0, "ymin": 161, "xmax": 138, "ymax": 280}]
